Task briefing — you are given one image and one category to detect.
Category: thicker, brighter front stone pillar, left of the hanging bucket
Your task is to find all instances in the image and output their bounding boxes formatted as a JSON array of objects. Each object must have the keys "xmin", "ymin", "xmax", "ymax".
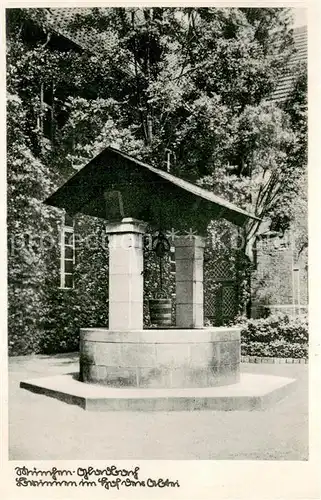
[{"xmin": 106, "ymin": 217, "xmax": 147, "ymax": 331}]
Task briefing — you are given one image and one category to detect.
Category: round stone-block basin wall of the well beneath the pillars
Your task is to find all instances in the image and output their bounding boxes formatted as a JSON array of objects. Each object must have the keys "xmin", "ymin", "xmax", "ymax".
[{"xmin": 80, "ymin": 327, "xmax": 240, "ymax": 388}]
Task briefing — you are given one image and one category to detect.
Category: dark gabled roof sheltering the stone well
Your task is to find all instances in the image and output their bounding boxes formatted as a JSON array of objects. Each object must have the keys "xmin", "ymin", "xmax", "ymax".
[{"xmin": 45, "ymin": 147, "xmax": 259, "ymax": 230}]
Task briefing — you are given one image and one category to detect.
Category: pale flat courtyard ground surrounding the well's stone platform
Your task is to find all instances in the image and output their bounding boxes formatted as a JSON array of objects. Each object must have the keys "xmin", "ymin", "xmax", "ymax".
[{"xmin": 9, "ymin": 354, "xmax": 308, "ymax": 460}]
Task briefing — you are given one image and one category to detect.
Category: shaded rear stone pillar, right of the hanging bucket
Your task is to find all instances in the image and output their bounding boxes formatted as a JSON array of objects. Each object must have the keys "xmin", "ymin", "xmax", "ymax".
[{"xmin": 174, "ymin": 235, "xmax": 205, "ymax": 328}]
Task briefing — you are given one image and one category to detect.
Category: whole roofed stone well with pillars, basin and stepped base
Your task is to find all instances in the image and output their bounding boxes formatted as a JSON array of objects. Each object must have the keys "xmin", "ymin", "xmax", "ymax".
[{"xmin": 20, "ymin": 148, "xmax": 293, "ymax": 411}]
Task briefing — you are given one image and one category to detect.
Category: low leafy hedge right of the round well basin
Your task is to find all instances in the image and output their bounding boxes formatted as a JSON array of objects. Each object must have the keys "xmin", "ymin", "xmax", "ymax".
[{"xmin": 240, "ymin": 315, "xmax": 309, "ymax": 358}]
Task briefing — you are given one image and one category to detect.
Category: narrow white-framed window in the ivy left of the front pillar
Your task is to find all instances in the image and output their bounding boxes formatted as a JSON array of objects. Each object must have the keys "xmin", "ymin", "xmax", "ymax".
[{"xmin": 60, "ymin": 214, "xmax": 75, "ymax": 289}]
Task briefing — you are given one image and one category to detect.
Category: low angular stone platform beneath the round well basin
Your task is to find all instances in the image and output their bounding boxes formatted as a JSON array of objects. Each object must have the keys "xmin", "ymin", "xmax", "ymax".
[{"xmin": 20, "ymin": 373, "xmax": 295, "ymax": 411}]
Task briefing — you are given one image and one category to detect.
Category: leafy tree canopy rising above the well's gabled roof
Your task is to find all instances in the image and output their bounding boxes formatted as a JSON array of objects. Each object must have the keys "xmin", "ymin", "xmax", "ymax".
[{"xmin": 8, "ymin": 8, "xmax": 306, "ymax": 252}]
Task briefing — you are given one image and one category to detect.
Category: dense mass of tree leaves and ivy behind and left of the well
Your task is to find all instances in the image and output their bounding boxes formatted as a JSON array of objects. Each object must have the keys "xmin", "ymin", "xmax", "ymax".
[{"xmin": 7, "ymin": 8, "xmax": 305, "ymax": 354}]
